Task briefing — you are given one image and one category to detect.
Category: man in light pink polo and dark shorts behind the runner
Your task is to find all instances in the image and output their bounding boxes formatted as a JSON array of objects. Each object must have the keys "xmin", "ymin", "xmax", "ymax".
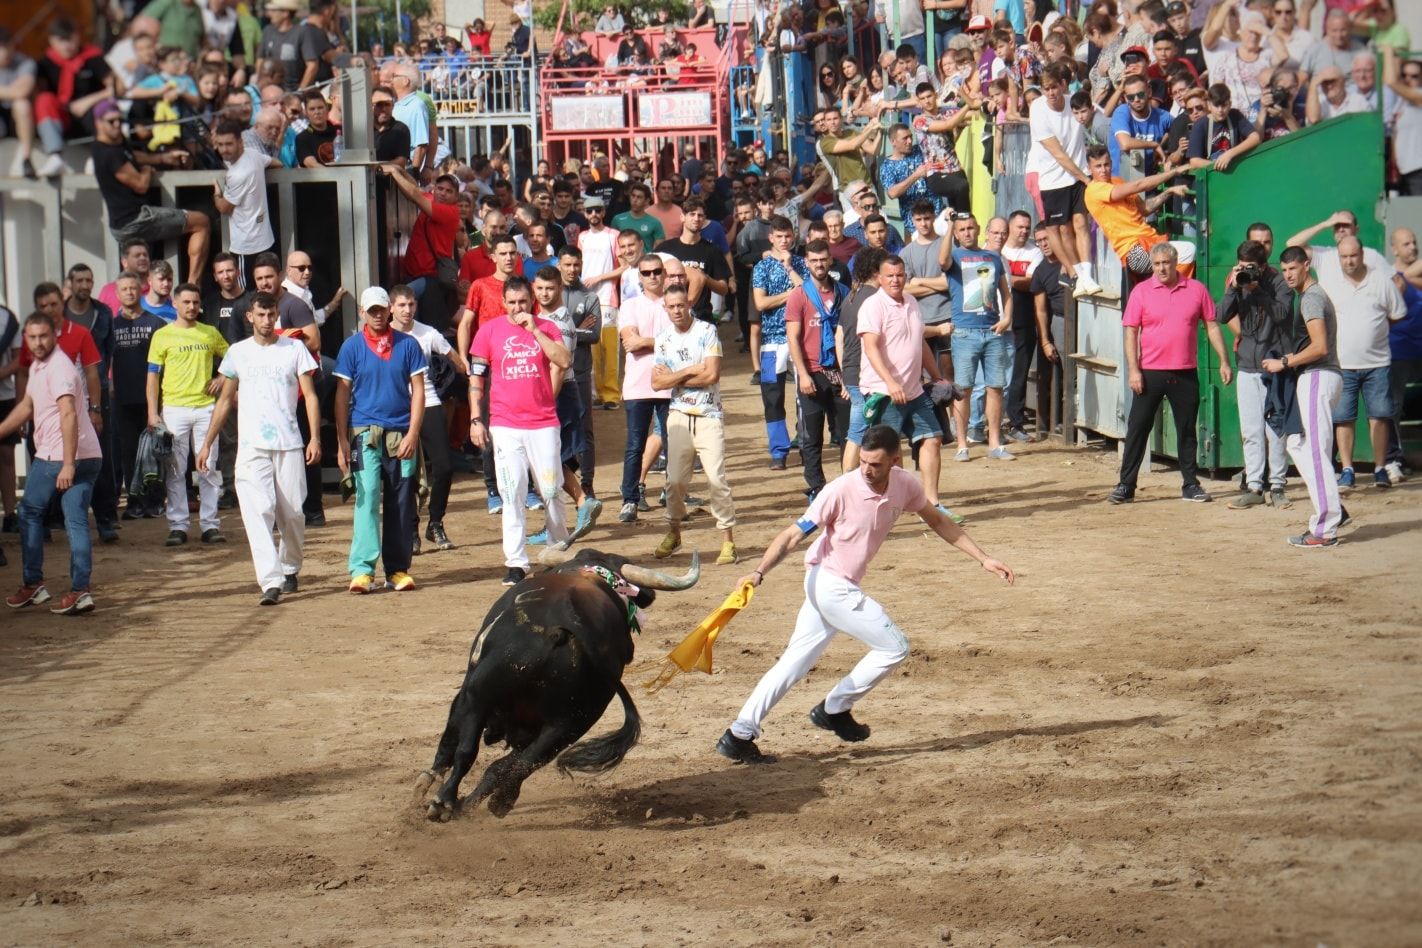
[{"xmin": 855, "ymin": 254, "xmax": 951, "ymax": 516}]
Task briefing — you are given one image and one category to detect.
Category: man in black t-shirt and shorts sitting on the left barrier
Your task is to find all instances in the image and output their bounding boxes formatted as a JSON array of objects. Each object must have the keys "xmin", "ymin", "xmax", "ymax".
[{"xmin": 92, "ymin": 99, "xmax": 212, "ymax": 281}]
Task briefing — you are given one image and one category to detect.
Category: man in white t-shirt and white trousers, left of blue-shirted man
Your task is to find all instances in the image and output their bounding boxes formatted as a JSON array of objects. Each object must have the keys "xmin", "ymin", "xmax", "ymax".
[{"xmin": 198, "ymin": 293, "xmax": 321, "ymax": 605}]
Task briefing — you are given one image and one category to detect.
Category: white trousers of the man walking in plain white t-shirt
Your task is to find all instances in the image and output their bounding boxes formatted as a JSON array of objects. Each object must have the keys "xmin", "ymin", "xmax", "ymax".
[{"xmin": 232, "ymin": 448, "xmax": 306, "ymax": 591}]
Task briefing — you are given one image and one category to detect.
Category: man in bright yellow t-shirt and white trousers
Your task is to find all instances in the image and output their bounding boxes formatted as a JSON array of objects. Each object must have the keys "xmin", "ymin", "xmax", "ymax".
[{"xmin": 148, "ymin": 283, "xmax": 228, "ymax": 546}]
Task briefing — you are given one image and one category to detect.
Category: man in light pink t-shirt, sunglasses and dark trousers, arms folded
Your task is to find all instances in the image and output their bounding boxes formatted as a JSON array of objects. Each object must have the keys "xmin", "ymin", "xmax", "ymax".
[{"xmin": 617, "ymin": 253, "xmax": 671, "ymax": 523}]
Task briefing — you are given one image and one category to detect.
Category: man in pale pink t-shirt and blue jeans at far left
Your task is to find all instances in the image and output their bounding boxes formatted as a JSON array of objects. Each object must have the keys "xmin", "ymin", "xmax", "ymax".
[{"xmin": 0, "ymin": 313, "xmax": 102, "ymax": 615}]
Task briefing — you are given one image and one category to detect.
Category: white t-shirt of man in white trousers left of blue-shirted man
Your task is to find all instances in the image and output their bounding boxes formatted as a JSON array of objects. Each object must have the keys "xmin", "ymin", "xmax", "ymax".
[{"xmin": 218, "ymin": 335, "xmax": 317, "ymax": 451}]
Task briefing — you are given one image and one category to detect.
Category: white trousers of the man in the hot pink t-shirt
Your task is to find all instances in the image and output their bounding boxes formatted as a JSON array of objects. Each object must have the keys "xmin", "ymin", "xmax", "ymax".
[{"xmin": 489, "ymin": 425, "xmax": 567, "ymax": 570}]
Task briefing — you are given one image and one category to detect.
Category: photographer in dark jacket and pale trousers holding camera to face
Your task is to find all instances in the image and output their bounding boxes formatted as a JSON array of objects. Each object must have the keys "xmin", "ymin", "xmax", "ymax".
[{"xmin": 1219, "ymin": 240, "xmax": 1294, "ymax": 510}]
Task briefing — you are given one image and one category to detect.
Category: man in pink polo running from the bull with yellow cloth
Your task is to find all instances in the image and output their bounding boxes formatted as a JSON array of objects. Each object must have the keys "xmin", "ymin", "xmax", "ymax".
[{"xmin": 715, "ymin": 425, "xmax": 1014, "ymax": 763}]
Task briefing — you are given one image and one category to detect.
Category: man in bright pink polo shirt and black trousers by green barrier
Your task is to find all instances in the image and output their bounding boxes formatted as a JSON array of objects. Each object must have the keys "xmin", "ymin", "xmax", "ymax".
[{"xmin": 1108, "ymin": 243, "xmax": 1233, "ymax": 503}]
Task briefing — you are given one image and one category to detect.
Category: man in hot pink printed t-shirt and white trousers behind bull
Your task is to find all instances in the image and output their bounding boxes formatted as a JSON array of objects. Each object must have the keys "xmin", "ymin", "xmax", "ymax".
[{"xmin": 469, "ymin": 276, "xmax": 573, "ymax": 586}]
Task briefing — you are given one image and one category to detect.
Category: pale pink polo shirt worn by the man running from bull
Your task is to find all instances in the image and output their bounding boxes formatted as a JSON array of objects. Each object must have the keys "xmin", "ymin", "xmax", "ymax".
[{"xmin": 799, "ymin": 468, "xmax": 929, "ymax": 584}]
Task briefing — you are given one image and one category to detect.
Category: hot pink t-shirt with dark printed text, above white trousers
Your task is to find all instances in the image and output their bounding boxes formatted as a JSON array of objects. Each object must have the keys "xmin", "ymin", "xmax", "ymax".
[{"xmin": 469, "ymin": 316, "xmax": 563, "ymax": 431}]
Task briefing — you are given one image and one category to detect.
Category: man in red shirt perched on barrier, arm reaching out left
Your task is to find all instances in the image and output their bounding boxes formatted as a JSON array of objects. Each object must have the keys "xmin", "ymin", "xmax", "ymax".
[{"xmin": 380, "ymin": 163, "xmax": 459, "ymax": 333}]
